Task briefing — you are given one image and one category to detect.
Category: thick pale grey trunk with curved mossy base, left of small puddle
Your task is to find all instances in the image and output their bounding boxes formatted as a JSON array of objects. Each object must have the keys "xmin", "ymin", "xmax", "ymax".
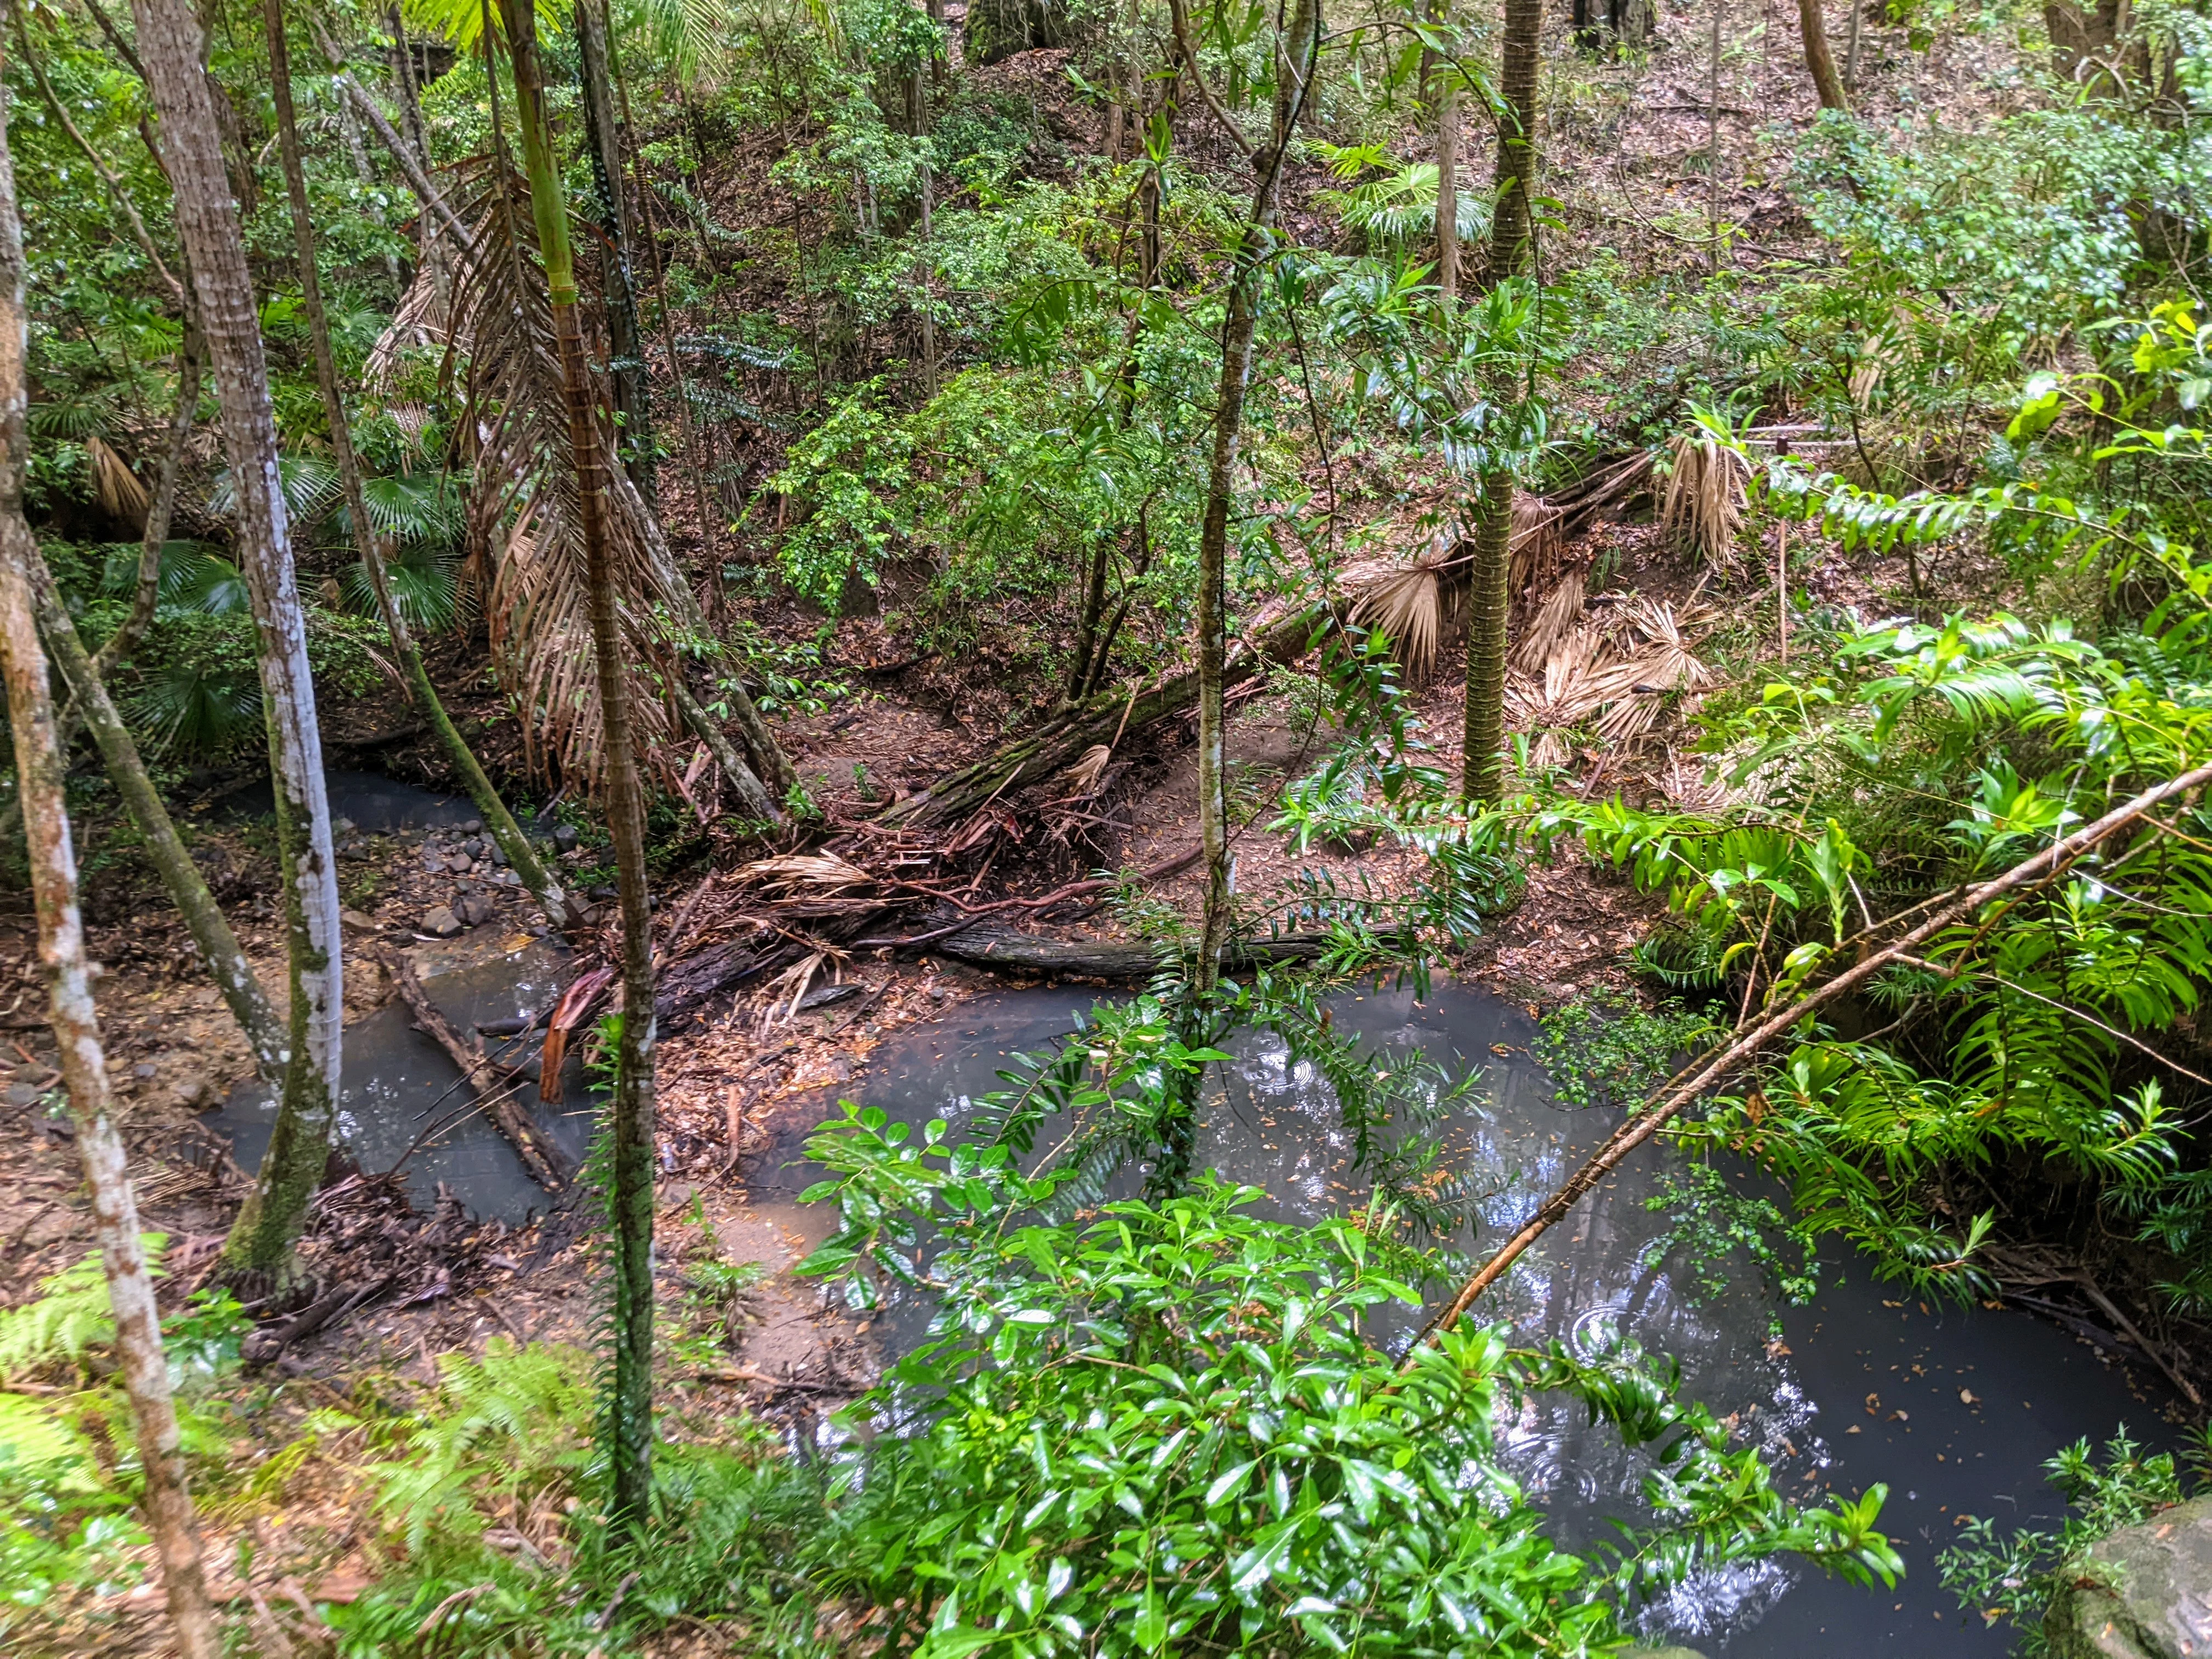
[{"xmin": 133, "ymin": 0, "xmax": 345, "ymax": 1285}]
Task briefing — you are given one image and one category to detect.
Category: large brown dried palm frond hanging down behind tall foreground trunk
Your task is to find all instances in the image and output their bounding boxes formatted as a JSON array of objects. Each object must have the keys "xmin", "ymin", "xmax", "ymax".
[{"xmin": 416, "ymin": 166, "xmax": 676, "ymax": 787}]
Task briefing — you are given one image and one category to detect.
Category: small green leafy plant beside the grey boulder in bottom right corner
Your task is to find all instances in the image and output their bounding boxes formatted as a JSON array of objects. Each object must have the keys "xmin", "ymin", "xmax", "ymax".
[{"xmin": 1936, "ymin": 1429, "xmax": 2212, "ymax": 1657}]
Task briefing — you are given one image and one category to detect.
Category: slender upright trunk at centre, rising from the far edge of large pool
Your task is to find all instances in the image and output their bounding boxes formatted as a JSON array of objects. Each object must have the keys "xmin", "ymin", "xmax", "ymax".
[{"xmin": 1188, "ymin": 0, "xmax": 1321, "ymax": 991}]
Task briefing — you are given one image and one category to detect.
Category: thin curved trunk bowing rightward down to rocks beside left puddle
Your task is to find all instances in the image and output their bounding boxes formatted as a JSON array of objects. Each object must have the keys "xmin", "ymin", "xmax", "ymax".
[{"xmin": 261, "ymin": 0, "xmax": 575, "ymax": 929}]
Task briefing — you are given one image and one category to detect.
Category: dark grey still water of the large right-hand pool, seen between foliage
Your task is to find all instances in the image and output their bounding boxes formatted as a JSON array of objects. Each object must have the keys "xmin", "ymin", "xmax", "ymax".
[{"xmin": 752, "ymin": 982, "xmax": 2168, "ymax": 1659}]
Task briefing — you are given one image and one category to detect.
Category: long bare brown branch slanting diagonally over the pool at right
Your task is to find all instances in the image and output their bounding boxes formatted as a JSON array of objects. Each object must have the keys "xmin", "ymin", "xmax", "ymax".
[{"xmin": 1407, "ymin": 765, "xmax": 2212, "ymax": 1365}]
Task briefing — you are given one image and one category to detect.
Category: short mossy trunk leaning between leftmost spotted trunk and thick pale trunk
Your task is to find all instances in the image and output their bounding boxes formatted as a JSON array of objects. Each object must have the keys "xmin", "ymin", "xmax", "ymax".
[{"xmin": 31, "ymin": 560, "xmax": 290, "ymax": 1084}]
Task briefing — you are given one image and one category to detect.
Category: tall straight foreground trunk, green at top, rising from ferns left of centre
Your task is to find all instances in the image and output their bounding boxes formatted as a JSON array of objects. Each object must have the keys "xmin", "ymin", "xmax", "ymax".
[{"xmin": 500, "ymin": 0, "xmax": 654, "ymax": 1535}]
